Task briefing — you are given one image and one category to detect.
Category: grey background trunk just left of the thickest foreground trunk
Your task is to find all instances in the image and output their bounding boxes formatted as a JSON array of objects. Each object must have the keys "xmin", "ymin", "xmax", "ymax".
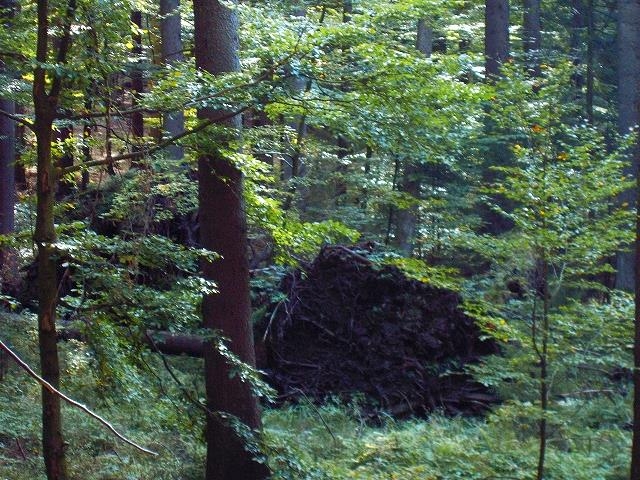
[{"xmin": 160, "ymin": 0, "xmax": 184, "ymax": 160}]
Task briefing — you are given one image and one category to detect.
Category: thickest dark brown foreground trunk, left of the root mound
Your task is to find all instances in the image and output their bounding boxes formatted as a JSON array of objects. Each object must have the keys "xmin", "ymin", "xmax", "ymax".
[{"xmin": 193, "ymin": 0, "xmax": 269, "ymax": 480}]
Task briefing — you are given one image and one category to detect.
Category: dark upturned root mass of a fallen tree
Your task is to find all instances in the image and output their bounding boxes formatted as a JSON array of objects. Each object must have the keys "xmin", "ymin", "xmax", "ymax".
[{"xmin": 266, "ymin": 246, "xmax": 497, "ymax": 416}]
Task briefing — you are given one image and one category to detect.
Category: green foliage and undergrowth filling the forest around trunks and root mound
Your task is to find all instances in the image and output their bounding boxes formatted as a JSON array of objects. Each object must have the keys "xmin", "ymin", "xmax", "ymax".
[{"xmin": 0, "ymin": 0, "xmax": 640, "ymax": 480}]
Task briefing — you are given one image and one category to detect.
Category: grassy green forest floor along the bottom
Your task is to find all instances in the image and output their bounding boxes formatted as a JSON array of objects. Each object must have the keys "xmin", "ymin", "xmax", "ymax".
[{"xmin": 0, "ymin": 315, "xmax": 631, "ymax": 480}]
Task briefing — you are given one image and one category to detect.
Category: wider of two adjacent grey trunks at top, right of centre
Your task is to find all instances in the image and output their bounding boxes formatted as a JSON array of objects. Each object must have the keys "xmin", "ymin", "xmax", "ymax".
[{"xmin": 484, "ymin": 0, "xmax": 509, "ymax": 78}]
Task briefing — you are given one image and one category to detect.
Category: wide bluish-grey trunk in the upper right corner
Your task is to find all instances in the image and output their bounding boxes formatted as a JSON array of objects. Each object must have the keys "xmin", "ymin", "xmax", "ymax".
[{"xmin": 615, "ymin": 0, "xmax": 640, "ymax": 291}]
